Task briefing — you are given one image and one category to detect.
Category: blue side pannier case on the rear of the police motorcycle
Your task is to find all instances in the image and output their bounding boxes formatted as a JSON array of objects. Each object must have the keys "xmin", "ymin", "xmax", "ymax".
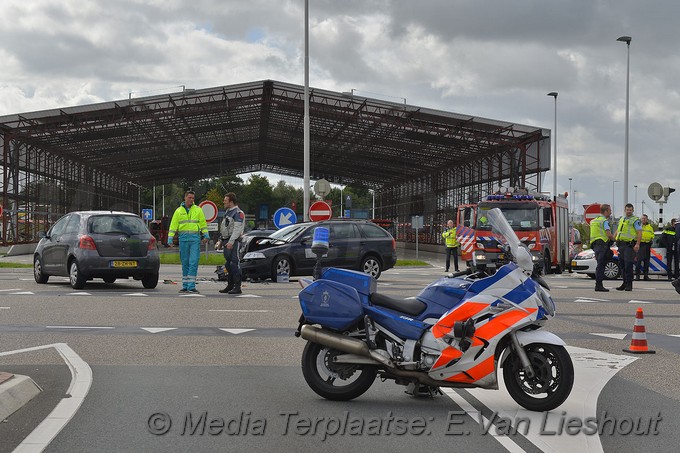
[{"xmin": 298, "ymin": 280, "xmax": 363, "ymax": 330}]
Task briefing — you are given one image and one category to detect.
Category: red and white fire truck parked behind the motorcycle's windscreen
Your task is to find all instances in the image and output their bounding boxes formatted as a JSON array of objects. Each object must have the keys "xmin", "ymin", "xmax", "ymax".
[{"xmin": 456, "ymin": 190, "xmax": 569, "ymax": 274}]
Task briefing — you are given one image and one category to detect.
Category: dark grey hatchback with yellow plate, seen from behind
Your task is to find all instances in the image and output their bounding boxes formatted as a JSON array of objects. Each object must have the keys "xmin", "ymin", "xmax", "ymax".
[{"xmin": 33, "ymin": 211, "xmax": 160, "ymax": 289}]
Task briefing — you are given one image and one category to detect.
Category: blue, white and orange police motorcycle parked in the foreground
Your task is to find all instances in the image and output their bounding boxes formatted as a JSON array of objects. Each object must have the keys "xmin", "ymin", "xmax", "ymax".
[{"xmin": 296, "ymin": 208, "xmax": 574, "ymax": 411}]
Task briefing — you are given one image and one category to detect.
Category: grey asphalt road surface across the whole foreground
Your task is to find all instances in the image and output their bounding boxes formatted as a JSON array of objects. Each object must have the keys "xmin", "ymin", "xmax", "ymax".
[{"xmin": 0, "ymin": 262, "xmax": 680, "ymax": 452}]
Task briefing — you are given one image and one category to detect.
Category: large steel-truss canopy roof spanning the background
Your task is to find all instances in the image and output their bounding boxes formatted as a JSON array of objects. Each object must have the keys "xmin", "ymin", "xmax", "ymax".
[{"xmin": 0, "ymin": 80, "xmax": 542, "ymax": 189}]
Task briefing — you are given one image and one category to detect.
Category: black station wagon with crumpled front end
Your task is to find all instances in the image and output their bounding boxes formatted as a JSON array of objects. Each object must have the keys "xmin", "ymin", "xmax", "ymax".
[{"xmin": 241, "ymin": 219, "xmax": 397, "ymax": 281}]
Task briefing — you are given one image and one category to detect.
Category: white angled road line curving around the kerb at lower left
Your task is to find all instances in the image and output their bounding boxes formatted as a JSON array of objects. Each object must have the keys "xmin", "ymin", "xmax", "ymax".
[{"xmin": 0, "ymin": 343, "xmax": 92, "ymax": 453}]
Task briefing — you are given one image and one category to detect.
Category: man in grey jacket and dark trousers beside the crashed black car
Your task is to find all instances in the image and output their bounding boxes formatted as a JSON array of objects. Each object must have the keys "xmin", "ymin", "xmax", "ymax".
[{"xmin": 215, "ymin": 192, "xmax": 246, "ymax": 294}]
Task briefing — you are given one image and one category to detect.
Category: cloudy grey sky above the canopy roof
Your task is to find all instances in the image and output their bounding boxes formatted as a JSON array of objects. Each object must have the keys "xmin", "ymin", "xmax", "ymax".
[{"xmin": 0, "ymin": 0, "xmax": 680, "ymax": 220}]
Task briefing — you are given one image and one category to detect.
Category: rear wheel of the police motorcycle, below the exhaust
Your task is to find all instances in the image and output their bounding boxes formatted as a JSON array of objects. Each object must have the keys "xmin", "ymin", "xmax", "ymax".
[{"xmin": 302, "ymin": 342, "xmax": 378, "ymax": 401}]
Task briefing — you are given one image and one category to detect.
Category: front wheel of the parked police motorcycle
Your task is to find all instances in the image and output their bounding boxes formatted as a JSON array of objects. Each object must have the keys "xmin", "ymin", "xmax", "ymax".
[{"xmin": 503, "ymin": 343, "xmax": 574, "ymax": 412}]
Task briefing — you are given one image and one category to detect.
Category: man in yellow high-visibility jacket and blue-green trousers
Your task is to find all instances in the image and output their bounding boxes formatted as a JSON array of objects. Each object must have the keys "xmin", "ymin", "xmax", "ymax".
[{"xmin": 168, "ymin": 190, "xmax": 209, "ymax": 293}]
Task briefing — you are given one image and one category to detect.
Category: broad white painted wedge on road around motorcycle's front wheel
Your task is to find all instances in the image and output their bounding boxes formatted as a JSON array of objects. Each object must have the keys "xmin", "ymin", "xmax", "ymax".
[{"xmin": 467, "ymin": 346, "xmax": 637, "ymax": 452}]
